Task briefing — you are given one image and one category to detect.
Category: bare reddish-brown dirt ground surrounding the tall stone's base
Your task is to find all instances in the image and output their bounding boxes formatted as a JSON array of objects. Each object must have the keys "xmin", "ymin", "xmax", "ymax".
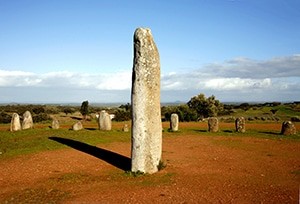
[{"xmin": 0, "ymin": 124, "xmax": 300, "ymax": 203}]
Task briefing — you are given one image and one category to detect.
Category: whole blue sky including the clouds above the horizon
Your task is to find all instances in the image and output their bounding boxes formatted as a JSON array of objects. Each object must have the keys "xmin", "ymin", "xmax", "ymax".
[{"xmin": 0, "ymin": 0, "xmax": 300, "ymax": 102}]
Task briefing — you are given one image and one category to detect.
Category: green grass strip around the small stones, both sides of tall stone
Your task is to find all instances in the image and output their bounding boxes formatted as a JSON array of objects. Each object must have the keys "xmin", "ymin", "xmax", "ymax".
[{"xmin": 0, "ymin": 122, "xmax": 300, "ymax": 159}]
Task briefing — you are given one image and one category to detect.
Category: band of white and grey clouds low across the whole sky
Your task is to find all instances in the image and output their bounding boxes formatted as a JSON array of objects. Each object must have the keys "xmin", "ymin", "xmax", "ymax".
[{"xmin": 0, "ymin": 55, "xmax": 300, "ymax": 102}]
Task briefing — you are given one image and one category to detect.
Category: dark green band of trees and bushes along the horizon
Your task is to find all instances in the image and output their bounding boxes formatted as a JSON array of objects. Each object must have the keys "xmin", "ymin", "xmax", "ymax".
[{"xmin": 0, "ymin": 94, "xmax": 300, "ymax": 123}]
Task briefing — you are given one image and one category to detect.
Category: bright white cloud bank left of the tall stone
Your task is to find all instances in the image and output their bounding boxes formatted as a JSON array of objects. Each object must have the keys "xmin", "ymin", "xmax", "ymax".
[{"xmin": 0, "ymin": 70, "xmax": 131, "ymax": 90}]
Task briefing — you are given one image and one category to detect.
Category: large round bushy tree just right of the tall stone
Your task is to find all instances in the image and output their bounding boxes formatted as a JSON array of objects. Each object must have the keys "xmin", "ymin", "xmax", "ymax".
[{"xmin": 187, "ymin": 93, "xmax": 223, "ymax": 118}]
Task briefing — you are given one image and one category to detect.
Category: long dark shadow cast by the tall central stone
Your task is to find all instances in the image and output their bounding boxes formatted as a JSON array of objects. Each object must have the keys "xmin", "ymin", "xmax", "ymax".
[{"xmin": 49, "ymin": 136, "xmax": 131, "ymax": 171}]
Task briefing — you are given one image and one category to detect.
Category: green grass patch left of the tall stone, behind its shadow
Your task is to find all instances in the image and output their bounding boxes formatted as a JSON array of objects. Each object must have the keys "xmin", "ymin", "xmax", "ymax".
[{"xmin": 0, "ymin": 124, "xmax": 130, "ymax": 159}]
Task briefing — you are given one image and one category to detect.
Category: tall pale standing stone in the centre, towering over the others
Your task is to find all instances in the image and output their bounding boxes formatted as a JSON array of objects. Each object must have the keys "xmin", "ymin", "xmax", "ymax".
[{"xmin": 131, "ymin": 28, "xmax": 162, "ymax": 174}]
